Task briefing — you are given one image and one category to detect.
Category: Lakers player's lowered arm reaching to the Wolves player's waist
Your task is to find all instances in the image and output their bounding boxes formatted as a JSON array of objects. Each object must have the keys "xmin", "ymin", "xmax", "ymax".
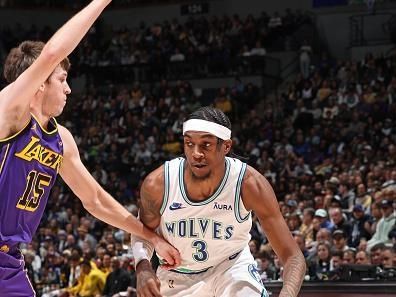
[{"xmin": 59, "ymin": 125, "xmax": 180, "ymax": 264}]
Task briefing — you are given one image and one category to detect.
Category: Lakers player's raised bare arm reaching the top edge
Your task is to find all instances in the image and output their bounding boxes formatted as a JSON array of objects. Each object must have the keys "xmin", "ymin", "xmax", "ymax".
[{"xmin": 0, "ymin": 0, "xmax": 111, "ymax": 137}]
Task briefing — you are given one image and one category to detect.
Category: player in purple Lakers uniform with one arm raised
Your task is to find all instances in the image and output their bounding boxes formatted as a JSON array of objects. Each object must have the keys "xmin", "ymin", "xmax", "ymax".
[{"xmin": 0, "ymin": 0, "xmax": 180, "ymax": 297}]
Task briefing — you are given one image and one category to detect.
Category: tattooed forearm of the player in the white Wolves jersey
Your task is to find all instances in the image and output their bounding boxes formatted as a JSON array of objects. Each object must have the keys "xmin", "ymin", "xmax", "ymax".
[{"xmin": 279, "ymin": 253, "xmax": 306, "ymax": 297}]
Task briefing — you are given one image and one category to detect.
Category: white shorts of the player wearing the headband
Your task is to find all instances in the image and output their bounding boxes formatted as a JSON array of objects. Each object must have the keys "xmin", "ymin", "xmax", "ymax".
[{"xmin": 157, "ymin": 247, "xmax": 268, "ymax": 297}]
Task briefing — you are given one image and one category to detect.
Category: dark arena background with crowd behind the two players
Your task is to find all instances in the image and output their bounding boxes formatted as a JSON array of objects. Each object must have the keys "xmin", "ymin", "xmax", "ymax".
[{"xmin": 0, "ymin": 0, "xmax": 396, "ymax": 297}]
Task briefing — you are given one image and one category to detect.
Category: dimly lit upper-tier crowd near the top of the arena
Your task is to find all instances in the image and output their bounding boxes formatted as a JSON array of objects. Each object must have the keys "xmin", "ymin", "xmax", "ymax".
[{"xmin": 0, "ymin": 9, "xmax": 312, "ymax": 81}]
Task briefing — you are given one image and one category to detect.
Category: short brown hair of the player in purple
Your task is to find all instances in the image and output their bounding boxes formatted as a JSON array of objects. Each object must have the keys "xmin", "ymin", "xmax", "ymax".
[{"xmin": 4, "ymin": 40, "xmax": 70, "ymax": 83}]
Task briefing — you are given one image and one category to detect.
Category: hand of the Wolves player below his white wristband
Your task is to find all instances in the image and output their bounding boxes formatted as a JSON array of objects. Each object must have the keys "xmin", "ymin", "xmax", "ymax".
[{"xmin": 136, "ymin": 260, "xmax": 162, "ymax": 297}]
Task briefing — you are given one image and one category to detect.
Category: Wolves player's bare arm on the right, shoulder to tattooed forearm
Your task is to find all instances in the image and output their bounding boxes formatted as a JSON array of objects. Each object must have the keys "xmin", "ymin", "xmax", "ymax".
[{"xmin": 242, "ymin": 167, "xmax": 306, "ymax": 297}]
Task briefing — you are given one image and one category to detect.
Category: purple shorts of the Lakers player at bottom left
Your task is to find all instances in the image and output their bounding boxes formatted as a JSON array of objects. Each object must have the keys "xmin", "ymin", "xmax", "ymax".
[{"xmin": 0, "ymin": 244, "xmax": 36, "ymax": 297}]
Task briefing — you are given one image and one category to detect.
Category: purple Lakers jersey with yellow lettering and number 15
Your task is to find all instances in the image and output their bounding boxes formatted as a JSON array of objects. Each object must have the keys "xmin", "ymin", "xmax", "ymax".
[{"xmin": 0, "ymin": 117, "xmax": 63, "ymax": 244}]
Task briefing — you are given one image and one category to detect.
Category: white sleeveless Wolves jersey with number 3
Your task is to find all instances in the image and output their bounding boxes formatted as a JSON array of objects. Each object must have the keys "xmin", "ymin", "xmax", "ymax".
[{"xmin": 160, "ymin": 157, "xmax": 252, "ymax": 273}]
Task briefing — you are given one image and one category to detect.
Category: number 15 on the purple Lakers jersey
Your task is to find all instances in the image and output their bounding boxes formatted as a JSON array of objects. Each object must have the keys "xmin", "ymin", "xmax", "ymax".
[{"xmin": 16, "ymin": 170, "xmax": 51, "ymax": 211}]
